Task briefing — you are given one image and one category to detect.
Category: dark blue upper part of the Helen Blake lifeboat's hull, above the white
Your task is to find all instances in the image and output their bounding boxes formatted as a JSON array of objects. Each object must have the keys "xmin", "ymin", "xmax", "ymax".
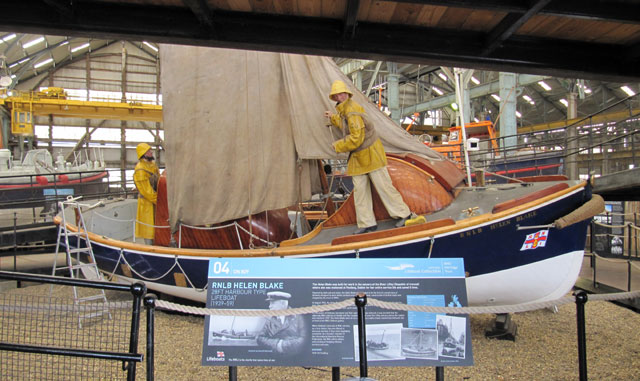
[{"xmin": 69, "ymin": 189, "xmax": 589, "ymax": 304}]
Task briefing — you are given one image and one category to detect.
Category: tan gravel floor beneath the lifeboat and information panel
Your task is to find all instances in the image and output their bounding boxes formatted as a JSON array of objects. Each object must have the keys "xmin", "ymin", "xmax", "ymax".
[{"xmin": 4, "ymin": 285, "xmax": 640, "ymax": 381}]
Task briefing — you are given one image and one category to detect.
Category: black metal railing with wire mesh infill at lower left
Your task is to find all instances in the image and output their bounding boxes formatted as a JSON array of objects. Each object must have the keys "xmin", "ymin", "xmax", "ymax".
[{"xmin": 0, "ymin": 271, "xmax": 154, "ymax": 380}]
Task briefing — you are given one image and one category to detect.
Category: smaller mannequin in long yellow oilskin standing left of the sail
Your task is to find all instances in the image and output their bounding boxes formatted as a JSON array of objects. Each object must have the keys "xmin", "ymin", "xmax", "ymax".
[{"xmin": 133, "ymin": 143, "xmax": 159, "ymax": 245}]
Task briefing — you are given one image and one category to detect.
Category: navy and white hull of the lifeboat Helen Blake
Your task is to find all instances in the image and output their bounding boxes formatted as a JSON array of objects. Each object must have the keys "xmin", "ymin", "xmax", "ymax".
[{"xmin": 65, "ymin": 184, "xmax": 589, "ymax": 305}]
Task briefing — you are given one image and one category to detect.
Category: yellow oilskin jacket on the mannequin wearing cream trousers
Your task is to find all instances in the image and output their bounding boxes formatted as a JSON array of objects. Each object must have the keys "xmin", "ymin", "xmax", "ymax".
[{"xmin": 331, "ymin": 98, "xmax": 387, "ymax": 176}]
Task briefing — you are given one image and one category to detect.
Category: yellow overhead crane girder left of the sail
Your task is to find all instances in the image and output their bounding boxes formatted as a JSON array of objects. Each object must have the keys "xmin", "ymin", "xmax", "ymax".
[{"xmin": 0, "ymin": 87, "xmax": 162, "ymax": 136}]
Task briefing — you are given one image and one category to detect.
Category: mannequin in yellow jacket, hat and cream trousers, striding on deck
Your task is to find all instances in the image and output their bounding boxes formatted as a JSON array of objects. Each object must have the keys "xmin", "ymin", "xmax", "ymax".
[{"xmin": 324, "ymin": 80, "xmax": 412, "ymax": 234}]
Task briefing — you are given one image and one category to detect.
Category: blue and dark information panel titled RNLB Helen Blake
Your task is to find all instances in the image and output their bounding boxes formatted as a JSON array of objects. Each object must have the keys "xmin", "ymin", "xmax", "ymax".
[{"xmin": 202, "ymin": 258, "xmax": 473, "ymax": 366}]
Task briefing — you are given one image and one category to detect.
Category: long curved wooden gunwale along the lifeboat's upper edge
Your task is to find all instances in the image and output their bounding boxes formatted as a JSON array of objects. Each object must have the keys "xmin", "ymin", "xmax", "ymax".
[{"xmin": 54, "ymin": 181, "xmax": 587, "ymax": 258}]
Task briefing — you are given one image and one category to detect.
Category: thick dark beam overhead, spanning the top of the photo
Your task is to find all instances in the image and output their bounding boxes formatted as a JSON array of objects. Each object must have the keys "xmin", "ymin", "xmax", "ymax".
[{"xmin": 0, "ymin": 0, "xmax": 640, "ymax": 82}]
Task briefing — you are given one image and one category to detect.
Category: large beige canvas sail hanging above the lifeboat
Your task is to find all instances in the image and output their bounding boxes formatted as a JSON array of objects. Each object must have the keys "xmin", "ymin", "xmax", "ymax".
[{"xmin": 161, "ymin": 45, "xmax": 442, "ymax": 226}]
